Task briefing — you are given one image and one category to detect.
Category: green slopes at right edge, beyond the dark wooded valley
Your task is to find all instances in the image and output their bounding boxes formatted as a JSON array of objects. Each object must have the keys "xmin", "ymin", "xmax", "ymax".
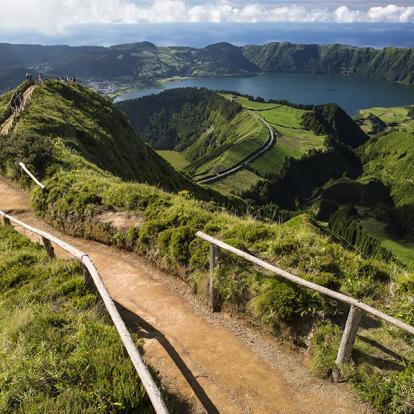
[{"xmin": 357, "ymin": 107, "xmax": 414, "ymax": 268}]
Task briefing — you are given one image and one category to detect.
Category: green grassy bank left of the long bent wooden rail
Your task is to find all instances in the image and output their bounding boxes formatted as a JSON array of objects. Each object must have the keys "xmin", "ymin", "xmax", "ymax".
[{"xmin": 0, "ymin": 227, "xmax": 158, "ymax": 414}]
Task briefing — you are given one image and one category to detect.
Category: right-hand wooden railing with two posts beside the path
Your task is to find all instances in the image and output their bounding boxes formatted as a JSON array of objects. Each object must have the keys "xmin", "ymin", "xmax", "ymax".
[{"xmin": 196, "ymin": 231, "xmax": 414, "ymax": 365}]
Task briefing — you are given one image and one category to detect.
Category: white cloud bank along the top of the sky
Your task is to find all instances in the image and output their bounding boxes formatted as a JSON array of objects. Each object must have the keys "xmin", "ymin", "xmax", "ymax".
[{"xmin": 0, "ymin": 0, "xmax": 414, "ymax": 35}]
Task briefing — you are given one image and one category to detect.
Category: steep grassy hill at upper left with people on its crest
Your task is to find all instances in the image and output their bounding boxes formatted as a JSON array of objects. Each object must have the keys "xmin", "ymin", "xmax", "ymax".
[{"xmin": 0, "ymin": 81, "xmax": 234, "ymax": 205}]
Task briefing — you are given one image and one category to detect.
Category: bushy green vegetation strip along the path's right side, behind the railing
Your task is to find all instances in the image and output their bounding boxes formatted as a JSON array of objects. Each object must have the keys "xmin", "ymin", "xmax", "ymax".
[{"xmin": 0, "ymin": 81, "xmax": 414, "ymax": 412}]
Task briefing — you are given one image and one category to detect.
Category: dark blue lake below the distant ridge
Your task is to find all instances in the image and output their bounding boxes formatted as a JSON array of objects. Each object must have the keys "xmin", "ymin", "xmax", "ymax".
[{"xmin": 116, "ymin": 73, "xmax": 414, "ymax": 115}]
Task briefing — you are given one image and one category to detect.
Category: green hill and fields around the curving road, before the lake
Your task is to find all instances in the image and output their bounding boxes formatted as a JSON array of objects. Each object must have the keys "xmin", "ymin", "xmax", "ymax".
[{"xmin": 117, "ymin": 88, "xmax": 334, "ymax": 194}]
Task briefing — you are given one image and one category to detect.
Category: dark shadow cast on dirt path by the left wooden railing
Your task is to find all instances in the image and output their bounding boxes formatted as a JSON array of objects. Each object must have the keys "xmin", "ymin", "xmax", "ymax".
[{"xmin": 116, "ymin": 302, "xmax": 219, "ymax": 414}]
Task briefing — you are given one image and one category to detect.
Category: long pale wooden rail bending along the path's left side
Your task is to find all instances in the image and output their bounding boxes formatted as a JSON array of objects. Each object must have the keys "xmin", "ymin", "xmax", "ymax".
[{"xmin": 0, "ymin": 210, "xmax": 168, "ymax": 414}]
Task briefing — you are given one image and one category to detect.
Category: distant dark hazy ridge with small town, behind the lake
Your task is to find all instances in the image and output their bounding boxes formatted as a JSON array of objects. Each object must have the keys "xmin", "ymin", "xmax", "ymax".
[{"xmin": 0, "ymin": 42, "xmax": 414, "ymax": 90}]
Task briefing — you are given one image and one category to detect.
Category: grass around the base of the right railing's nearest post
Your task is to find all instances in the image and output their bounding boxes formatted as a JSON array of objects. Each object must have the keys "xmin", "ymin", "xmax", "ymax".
[{"xmin": 311, "ymin": 323, "xmax": 414, "ymax": 414}]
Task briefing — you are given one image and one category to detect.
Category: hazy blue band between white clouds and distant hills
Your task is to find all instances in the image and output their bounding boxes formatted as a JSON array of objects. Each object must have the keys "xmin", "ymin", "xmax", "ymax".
[{"xmin": 0, "ymin": 23, "xmax": 414, "ymax": 49}]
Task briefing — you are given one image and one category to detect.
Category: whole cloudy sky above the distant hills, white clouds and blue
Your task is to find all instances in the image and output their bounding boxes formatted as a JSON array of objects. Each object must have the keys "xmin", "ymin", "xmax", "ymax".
[{"xmin": 0, "ymin": 0, "xmax": 414, "ymax": 47}]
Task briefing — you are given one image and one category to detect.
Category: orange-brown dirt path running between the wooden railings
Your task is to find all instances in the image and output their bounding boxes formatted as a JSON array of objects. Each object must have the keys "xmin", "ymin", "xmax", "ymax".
[{"xmin": 0, "ymin": 180, "xmax": 371, "ymax": 414}]
